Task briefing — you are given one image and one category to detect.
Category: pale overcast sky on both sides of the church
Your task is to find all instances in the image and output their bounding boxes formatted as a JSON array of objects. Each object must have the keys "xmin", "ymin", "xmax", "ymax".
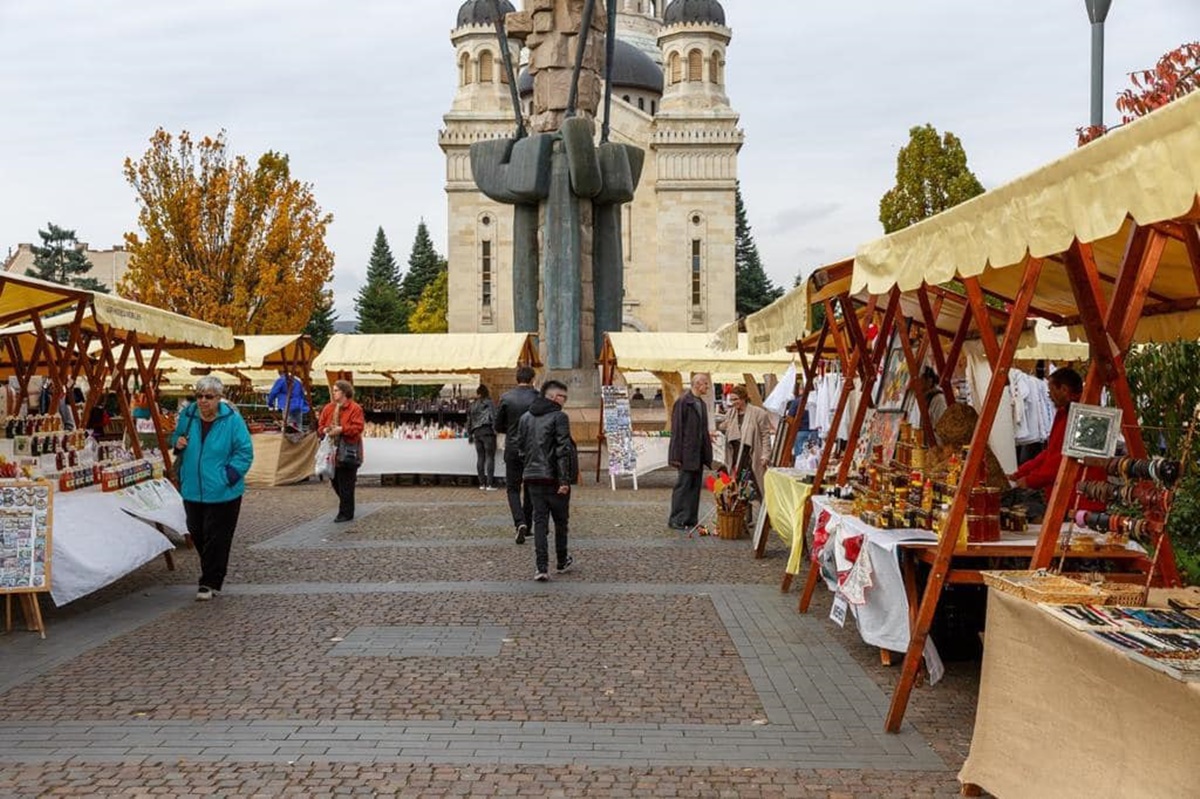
[{"xmin": 0, "ymin": 0, "xmax": 1200, "ymax": 320}]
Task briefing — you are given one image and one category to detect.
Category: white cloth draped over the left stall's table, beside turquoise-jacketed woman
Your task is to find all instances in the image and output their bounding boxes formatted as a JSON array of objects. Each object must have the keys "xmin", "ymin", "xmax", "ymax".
[{"xmin": 50, "ymin": 480, "xmax": 187, "ymax": 599}]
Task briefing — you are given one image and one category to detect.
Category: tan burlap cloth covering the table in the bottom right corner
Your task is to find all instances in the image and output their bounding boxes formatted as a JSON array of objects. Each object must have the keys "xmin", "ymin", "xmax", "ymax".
[{"xmin": 959, "ymin": 590, "xmax": 1200, "ymax": 798}]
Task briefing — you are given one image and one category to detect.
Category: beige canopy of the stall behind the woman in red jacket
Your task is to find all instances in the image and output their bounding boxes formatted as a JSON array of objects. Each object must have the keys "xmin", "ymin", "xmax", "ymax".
[{"xmin": 312, "ymin": 334, "xmax": 539, "ymax": 383}]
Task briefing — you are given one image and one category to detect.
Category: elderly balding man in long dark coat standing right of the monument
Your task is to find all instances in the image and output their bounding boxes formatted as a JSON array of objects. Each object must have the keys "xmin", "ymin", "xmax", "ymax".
[{"xmin": 667, "ymin": 374, "xmax": 713, "ymax": 530}]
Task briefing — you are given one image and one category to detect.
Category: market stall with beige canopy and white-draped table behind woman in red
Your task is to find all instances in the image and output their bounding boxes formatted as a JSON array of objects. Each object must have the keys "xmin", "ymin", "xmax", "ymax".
[{"xmin": 312, "ymin": 334, "xmax": 541, "ymax": 476}]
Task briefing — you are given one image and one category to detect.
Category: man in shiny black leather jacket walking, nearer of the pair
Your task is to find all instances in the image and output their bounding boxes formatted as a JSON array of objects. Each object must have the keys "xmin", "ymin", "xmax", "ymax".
[{"xmin": 517, "ymin": 380, "xmax": 580, "ymax": 582}]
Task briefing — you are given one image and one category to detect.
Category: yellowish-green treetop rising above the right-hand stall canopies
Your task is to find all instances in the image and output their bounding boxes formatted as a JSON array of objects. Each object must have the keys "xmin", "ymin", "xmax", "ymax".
[{"xmin": 880, "ymin": 124, "xmax": 984, "ymax": 233}]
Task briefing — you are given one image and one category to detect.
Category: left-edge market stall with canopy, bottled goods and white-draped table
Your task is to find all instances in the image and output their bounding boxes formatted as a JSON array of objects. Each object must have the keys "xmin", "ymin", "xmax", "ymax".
[{"xmin": 0, "ymin": 274, "xmax": 234, "ymax": 625}]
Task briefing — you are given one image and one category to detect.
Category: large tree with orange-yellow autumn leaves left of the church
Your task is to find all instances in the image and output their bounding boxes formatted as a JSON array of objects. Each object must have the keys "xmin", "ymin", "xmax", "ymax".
[{"xmin": 119, "ymin": 128, "xmax": 334, "ymax": 335}]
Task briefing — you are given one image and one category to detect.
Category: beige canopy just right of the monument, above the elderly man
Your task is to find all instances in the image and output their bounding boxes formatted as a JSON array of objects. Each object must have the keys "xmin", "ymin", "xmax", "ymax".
[{"xmin": 600, "ymin": 332, "xmax": 792, "ymax": 374}]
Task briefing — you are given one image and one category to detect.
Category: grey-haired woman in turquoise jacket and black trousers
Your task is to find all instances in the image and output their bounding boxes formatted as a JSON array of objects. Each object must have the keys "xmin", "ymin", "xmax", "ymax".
[{"xmin": 170, "ymin": 374, "xmax": 254, "ymax": 602}]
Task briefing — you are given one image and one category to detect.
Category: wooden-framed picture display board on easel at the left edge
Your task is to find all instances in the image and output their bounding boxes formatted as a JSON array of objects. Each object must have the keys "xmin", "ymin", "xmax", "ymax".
[{"xmin": 0, "ymin": 480, "xmax": 54, "ymax": 638}]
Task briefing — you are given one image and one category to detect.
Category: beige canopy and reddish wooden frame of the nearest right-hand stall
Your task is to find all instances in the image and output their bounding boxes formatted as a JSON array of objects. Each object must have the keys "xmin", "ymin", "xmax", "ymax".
[{"xmin": 852, "ymin": 88, "xmax": 1200, "ymax": 734}]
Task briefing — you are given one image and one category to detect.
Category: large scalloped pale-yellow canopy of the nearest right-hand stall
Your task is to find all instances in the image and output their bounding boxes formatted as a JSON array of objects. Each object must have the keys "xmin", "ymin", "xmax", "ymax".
[{"xmin": 852, "ymin": 92, "xmax": 1200, "ymax": 341}]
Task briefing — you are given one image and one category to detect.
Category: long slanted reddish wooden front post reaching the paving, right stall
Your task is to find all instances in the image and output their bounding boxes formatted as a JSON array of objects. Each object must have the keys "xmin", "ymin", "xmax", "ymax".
[{"xmin": 884, "ymin": 258, "xmax": 1043, "ymax": 732}]
